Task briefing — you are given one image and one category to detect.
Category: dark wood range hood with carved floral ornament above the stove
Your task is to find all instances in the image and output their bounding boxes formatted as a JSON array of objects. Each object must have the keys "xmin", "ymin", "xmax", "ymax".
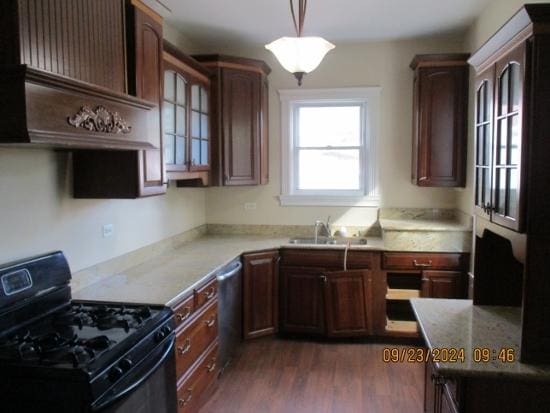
[{"xmin": 0, "ymin": 0, "xmax": 160, "ymax": 150}]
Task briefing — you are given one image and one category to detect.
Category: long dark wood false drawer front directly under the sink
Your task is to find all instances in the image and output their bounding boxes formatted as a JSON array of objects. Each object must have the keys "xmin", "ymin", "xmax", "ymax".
[{"xmin": 281, "ymin": 248, "xmax": 378, "ymax": 269}]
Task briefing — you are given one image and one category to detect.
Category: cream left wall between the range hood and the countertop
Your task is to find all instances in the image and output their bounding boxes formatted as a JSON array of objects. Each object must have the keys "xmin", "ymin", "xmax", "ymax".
[{"xmin": 0, "ymin": 24, "xmax": 206, "ymax": 271}]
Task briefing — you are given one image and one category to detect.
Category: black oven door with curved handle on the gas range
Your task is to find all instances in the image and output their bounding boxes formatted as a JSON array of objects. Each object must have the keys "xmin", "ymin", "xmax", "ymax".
[{"xmin": 92, "ymin": 333, "xmax": 177, "ymax": 413}]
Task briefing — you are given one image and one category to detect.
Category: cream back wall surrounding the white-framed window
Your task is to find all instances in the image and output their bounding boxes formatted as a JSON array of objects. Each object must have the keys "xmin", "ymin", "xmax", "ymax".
[{"xmin": 206, "ymin": 36, "xmax": 470, "ymax": 225}]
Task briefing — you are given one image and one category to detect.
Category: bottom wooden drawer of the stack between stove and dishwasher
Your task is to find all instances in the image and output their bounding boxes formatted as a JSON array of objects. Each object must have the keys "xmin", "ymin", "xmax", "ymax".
[{"xmin": 178, "ymin": 341, "xmax": 219, "ymax": 413}]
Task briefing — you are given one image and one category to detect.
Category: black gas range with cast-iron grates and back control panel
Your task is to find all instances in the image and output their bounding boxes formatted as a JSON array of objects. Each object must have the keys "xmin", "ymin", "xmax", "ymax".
[{"xmin": 0, "ymin": 252, "xmax": 176, "ymax": 413}]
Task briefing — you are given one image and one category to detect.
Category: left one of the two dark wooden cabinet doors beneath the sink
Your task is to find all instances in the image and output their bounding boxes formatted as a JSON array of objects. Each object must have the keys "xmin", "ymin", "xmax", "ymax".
[{"xmin": 280, "ymin": 266, "xmax": 325, "ymax": 334}]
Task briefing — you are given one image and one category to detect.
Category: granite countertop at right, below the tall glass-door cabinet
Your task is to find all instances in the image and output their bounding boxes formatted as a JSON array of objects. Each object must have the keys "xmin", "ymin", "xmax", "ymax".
[{"xmin": 411, "ymin": 298, "xmax": 550, "ymax": 380}]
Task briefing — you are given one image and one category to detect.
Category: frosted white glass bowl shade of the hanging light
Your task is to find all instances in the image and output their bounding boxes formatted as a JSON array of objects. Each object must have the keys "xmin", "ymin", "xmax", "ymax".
[{"xmin": 265, "ymin": 37, "xmax": 334, "ymax": 74}]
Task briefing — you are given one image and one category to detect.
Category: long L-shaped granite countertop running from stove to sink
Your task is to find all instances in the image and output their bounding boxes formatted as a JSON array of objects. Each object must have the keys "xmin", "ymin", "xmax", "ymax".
[{"xmin": 73, "ymin": 235, "xmax": 383, "ymax": 306}]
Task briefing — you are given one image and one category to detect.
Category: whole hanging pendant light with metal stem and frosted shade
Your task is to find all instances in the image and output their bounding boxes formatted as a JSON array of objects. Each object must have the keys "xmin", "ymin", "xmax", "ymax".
[{"xmin": 265, "ymin": 0, "xmax": 334, "ymax": 86}]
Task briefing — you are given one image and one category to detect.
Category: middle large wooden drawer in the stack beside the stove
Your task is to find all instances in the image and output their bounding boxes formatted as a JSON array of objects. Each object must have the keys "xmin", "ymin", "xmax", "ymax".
[{"xmin": 176, "ymin": 301, "xmax": 218, "ymax": 378}]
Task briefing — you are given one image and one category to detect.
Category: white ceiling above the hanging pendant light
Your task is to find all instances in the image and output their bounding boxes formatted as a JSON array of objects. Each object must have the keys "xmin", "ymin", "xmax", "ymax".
[{"xmin": 146, "ymin": 0, "xmax": 491, "ymax": 46}]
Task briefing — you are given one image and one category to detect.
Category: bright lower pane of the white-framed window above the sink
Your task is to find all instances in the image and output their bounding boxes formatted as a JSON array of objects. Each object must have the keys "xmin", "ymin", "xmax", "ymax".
[{"xmin": 298, "ymin": 149, "xmax": 361, "ymax": 190}]
